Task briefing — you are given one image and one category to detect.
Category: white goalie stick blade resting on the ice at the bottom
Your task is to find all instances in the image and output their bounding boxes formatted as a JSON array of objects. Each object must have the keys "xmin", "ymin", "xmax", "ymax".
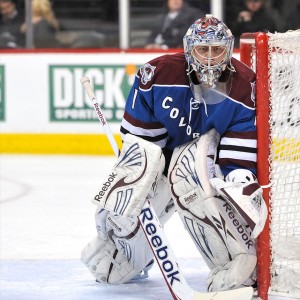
[{"xmin": 192, "ymin": 287, "xmax": 253, "ymax": 300}]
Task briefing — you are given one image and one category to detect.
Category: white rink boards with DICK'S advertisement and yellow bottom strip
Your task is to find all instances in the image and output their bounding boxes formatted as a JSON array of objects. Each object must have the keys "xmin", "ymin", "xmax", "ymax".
[{"xmin": 0, "ymin": 49, "xmax": 239, "ymax": 154}]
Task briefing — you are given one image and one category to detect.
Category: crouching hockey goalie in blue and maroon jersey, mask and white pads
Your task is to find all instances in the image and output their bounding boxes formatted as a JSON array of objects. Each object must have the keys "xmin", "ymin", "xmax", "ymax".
[{"xmin": 82, "ymin": 15, "xmax": 267, "ymax": 292}]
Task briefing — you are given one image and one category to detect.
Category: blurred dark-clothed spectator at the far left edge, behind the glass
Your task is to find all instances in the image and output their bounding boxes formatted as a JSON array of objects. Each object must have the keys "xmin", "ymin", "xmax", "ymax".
[{"xmin": 0, "ymin": 0, "xmax": 24, "ymax": 48}]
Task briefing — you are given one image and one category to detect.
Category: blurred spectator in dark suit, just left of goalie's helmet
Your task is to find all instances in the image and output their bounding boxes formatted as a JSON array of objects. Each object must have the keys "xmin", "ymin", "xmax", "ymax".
[{"xmin": 145, "ymin": 0, "xmax": 205, "ymax": 49}]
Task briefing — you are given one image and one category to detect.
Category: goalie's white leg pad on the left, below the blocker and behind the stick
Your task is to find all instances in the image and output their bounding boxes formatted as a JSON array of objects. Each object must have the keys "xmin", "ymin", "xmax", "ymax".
[{"xmin": 82, "ymin": 176, "xmax": 175, "ymax": 284}]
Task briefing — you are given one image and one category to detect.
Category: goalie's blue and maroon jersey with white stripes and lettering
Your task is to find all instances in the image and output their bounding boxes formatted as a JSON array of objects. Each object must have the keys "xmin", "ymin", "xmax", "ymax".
[{"xmin": 121, "ymin": 53, "xmax": 257, "ymax": 175}]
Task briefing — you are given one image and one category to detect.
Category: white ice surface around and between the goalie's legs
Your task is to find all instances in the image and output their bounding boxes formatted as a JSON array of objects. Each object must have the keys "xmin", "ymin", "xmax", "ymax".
[{"xmin": 0, "ymin": 155, "xmax": 294, "ymax": 300}]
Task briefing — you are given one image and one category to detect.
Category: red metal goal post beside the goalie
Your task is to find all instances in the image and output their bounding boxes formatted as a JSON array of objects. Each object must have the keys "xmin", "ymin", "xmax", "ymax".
[{"xmin": 240, "ymin": 33, "xmax": 270, "ymax": 299}]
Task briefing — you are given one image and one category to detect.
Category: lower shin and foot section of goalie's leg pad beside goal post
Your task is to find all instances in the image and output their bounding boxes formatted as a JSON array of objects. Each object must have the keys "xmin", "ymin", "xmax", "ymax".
[{"xmin": 175, "ymin": 197, "xmax": 256, "ymax": 291}]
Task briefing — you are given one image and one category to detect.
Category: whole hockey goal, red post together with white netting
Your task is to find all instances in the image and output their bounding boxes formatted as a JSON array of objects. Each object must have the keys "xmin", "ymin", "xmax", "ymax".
[{"xmin": 240, "ymin": 30, "xmax": 300, "ymax": 299}]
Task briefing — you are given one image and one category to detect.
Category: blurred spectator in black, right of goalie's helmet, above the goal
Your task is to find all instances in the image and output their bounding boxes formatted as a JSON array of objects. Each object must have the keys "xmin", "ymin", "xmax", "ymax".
[{"xmin": 231, "ymin": 0, "xmax": 277, "ymax": 47}]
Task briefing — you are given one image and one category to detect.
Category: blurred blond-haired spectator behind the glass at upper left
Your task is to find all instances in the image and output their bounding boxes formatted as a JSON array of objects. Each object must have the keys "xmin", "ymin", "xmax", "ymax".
[{"xmin": 21, "ymin": 0, "xmax": 60, "ymax": 48}]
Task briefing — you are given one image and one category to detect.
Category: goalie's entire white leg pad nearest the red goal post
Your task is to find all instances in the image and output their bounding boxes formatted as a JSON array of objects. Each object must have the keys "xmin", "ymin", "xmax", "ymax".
[{"xmin": 169, "ymin": 130, "xmax": 256, "ymax": 290}]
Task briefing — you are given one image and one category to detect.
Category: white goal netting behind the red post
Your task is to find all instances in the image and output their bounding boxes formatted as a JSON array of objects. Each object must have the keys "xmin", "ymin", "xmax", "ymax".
[{"xmin": 268, "ymin": 30, "xmax": 300, "ymax": 298}]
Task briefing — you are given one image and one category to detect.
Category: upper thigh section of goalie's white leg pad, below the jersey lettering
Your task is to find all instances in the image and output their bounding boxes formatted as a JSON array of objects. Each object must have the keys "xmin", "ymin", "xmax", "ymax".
[{"xmin": 168, "ymin": 129, "xmax": 219, "ymax": 209}]
